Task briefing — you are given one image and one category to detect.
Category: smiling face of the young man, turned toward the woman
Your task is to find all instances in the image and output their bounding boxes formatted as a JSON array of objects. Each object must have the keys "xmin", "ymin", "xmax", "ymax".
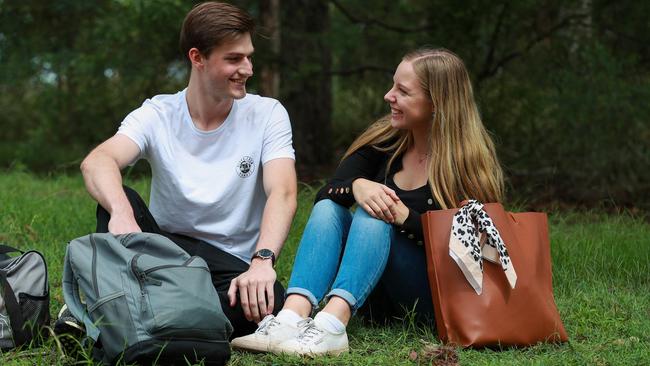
[{"xmin": 201, "ymin": 33, "xmax": 254, "ymax": 99}]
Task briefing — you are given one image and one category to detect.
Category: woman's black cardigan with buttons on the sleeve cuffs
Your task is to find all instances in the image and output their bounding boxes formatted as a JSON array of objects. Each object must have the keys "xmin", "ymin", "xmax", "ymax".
[{"xmin": 316, "ymin": 145, "xmax": 440, "ymax": 244}]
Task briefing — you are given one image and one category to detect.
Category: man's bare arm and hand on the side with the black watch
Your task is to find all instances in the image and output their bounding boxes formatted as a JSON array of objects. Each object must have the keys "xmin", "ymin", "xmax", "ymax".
[{"xmin": 228, "ymin": 158, "xmax": 298, "ymax": 322}]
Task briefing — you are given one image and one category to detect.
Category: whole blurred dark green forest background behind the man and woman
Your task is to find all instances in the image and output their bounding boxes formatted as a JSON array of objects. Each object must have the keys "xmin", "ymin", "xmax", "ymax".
[{"xmin": 0, "ymin": 0, "xmax": 650, "ymax": 209}]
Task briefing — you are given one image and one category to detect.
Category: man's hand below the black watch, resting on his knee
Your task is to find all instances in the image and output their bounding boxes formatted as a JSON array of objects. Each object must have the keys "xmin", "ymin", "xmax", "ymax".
[{"xmin": 228, "ymin": 258, "xmax": 277, "ymax": 323}]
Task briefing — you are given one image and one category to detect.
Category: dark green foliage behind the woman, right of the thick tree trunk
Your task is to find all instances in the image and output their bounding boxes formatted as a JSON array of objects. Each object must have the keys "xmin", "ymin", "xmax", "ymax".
[{"xmin": 332, "ymin": 0, "xmax": 650, "ymax": 209}]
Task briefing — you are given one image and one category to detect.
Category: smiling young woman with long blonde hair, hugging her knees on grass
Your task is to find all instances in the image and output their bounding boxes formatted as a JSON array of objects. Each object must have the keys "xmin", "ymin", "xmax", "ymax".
[{"xmin": 232, "ymin": 49, "xmax": 503, "ymax": 355}]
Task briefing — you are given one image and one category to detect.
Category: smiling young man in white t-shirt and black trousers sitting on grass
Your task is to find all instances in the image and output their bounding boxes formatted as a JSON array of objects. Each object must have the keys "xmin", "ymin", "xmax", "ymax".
[{"xmin": 71, "ymin": 2, "xmax": 297, "ymax": 336}]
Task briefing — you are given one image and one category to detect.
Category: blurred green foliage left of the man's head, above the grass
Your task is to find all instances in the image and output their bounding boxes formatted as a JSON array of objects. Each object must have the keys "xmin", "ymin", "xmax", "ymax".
[{"xmin": 0, "ymin": 0, "xmax": 188, "ymax": 170}]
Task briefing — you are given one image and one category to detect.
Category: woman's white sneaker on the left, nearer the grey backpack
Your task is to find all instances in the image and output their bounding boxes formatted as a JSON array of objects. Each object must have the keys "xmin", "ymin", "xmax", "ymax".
[{"xmin": 230, "ymin": 315, "xmax": 299, "ymax": 352}]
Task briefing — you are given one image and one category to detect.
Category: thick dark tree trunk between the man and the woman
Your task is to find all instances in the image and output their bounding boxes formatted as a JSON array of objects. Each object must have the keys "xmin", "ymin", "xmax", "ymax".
[{"xmin": 280, "ymin": 0, "xmax": 332, "ymax": 175}]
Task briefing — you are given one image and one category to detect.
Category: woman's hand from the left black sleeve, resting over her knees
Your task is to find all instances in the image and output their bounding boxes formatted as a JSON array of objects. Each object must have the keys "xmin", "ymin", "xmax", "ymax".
[{"xmin": 352, "ymin": 178, "xmax": 398, "ymax": 224}]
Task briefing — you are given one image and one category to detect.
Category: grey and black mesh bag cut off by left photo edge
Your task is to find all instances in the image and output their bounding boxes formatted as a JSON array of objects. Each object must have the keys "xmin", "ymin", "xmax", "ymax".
[{"xmin": 0, "ymin": 245, "xmax": 50, "ymax": 351}]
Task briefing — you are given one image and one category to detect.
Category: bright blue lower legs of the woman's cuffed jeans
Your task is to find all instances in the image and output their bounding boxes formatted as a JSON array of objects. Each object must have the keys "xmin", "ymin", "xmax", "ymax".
[{"xmin": 286, "ymin": 199, "xmax": 395, "ymax": 313}]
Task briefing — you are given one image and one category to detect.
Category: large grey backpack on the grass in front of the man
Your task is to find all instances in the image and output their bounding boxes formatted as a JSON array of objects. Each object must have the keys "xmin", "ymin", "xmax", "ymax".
[{"xmin": 63, "ymin": 233, "xmax": 232, "ymax": 365}]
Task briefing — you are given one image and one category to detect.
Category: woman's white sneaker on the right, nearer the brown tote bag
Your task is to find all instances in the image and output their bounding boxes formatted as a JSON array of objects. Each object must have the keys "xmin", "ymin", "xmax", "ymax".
[{"xmin": 273, "ymin": 318, "xmax": 348, "ymax": 356}]
